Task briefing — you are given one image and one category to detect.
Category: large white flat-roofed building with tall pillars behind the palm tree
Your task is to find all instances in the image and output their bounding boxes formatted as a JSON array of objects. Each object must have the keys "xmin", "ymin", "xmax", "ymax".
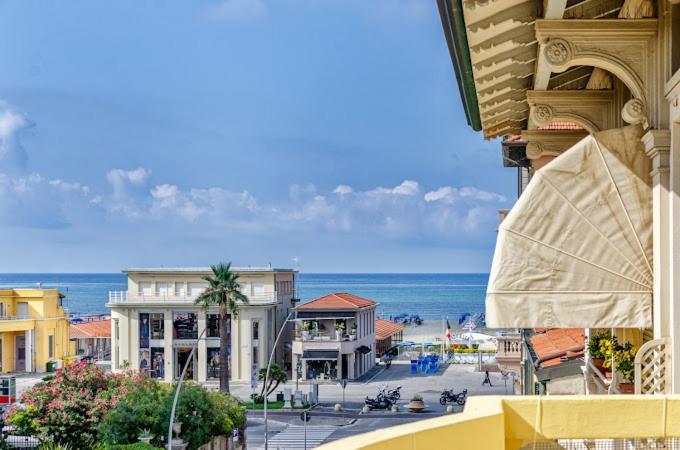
[{"xmin": 107, "ymin": 267, "xmax": 295, "ymax": 382}]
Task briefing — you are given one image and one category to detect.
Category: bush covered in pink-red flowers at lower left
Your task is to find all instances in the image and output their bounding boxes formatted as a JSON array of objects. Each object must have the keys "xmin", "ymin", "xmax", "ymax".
[{"xmin": 5, "ymin": 362, "xmax": 145, "ymax": 448}]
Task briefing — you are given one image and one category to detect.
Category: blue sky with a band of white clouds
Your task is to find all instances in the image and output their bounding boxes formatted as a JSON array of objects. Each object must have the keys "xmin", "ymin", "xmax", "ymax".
[{"xmin": 0, "ymin": 0, "xmax": 516, "ymax": 273}]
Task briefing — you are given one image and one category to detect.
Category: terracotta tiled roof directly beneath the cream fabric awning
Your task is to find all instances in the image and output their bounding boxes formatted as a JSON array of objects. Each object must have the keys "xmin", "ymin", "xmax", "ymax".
[{"xmin": 531, "ymin": 328, "xmax": 585, "ymax": 367}]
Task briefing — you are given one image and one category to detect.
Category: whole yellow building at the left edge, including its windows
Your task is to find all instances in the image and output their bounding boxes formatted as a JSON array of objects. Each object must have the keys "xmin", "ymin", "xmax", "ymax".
[{"xmin": 0, "ymin": 289, "xmax": 69, "ymax": 373}]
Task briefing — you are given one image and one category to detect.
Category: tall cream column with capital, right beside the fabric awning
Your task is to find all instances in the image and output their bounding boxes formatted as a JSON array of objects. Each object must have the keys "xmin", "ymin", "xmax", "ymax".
[{"xmin": 642, "ymin": 130, "xmax": 671, "ymax": 339}]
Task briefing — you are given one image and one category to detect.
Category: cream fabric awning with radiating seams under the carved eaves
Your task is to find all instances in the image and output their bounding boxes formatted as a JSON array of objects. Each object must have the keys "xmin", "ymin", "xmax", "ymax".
[{"xmin": 486, "ymin": 126, "xmax": 652, "ymax": 328}]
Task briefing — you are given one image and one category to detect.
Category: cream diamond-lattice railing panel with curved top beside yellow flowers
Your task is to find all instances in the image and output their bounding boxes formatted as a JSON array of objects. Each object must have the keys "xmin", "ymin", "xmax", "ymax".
[{"xmin": 635, "ymin": 338, "xmax": 671, "ymax": 394}]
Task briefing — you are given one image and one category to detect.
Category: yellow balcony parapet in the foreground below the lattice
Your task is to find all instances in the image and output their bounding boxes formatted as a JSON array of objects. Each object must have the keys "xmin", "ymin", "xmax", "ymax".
[{"xmin": 319, "ymin": 395, "xmax": 680, "ymax": 450}]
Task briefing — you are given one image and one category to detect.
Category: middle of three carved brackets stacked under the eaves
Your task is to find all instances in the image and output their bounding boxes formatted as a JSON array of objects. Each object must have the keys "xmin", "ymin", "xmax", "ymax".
[{"xmin": 527, "ymin": 90, "xmax": 618, "ymax": 133}]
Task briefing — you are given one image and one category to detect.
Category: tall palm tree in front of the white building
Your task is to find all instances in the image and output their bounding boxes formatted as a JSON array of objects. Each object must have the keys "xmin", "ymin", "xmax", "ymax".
[{"xmin": 196, "ymin": 263, "xmax": 248, "ymax": 392}]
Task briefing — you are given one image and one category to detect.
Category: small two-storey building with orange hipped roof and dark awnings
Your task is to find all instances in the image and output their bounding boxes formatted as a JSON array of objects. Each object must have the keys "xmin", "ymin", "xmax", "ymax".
[{"xmin": 293, "ymin": 292, "xmax": 378, "ymax": 381}]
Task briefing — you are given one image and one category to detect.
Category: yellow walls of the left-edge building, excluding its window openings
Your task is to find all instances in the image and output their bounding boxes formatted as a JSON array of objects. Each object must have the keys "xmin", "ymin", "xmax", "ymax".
[{"xmin": 0, "ymin": 289, "xmax": 72, "ymax": 372}]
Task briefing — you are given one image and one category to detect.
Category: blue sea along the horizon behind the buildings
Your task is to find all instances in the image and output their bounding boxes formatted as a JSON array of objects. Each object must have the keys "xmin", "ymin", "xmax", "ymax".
[{"xmin": 0, "ymin": 273, "xmax": 489, "ymax": 322}]
